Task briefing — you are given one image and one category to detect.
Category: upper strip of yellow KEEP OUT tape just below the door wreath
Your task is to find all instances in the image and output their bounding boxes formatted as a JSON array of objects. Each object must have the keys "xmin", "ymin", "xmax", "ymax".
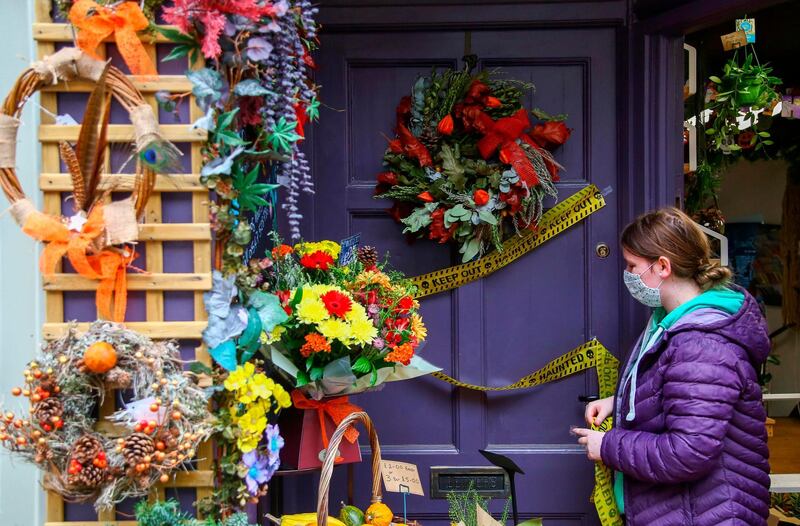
[{"xmin": 411, "ymin": 185, "xmax": 605, "ymax": 298}]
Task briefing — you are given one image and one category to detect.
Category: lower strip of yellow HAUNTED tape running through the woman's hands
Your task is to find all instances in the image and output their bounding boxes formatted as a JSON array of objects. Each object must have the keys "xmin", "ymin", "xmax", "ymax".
[{"xmin": 433, "ymin": 340, "xmax": 623, "ymax": 526}]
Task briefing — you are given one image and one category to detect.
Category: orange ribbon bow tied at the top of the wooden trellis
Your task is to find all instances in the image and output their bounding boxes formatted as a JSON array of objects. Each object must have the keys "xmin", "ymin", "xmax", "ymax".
[{"xmin": 69, "ymin": 0, "xmax": 158, "ymax": 75}]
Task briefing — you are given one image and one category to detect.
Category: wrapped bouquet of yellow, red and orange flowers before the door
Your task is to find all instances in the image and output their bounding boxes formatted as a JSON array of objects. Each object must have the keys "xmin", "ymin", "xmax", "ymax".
[{"xmin": 250, "ymin": 241, "xmax": 437, "ymax": 399}]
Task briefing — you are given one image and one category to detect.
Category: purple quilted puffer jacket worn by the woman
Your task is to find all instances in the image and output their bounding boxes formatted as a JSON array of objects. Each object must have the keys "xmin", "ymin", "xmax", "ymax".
[{"xmin": 601, "ymin": 288, "xmax": 770, "ymax": 526}]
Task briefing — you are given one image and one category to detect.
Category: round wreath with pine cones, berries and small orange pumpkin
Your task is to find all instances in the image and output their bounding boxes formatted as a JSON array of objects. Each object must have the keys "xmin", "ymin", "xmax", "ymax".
[{"xmin": 0, "ymin": 321, "xmax": 211, "ymax": 509}]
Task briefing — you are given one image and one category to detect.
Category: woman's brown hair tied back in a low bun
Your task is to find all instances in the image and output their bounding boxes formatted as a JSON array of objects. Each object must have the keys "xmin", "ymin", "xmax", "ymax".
[{"xmin": 621, "ymin": 207, "xmax": 732, "ymax": 290}]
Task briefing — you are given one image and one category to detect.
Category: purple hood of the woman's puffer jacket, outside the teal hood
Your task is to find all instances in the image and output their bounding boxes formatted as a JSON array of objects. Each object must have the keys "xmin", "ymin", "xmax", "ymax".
[{"xmin": 667, "ymin": 285, "xmax": 771, "ymax": 366}]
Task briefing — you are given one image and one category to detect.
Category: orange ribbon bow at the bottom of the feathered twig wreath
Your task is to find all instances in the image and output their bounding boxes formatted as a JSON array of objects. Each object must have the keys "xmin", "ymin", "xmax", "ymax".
[{"xmin": 22, "ymin": 205, "xmax": 136, "ymax": 322}]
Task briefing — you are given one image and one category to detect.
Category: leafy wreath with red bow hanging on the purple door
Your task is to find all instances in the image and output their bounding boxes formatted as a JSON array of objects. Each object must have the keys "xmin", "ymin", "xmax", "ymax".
[{"xmin": 375, "ymin": 70, "xmax": 571, "ymax": 262}]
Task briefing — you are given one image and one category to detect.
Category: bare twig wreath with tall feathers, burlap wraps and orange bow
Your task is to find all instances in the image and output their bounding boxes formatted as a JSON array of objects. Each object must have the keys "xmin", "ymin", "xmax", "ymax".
[{"xmin": 0, "ymin": 48, "xmax": 180, "ymax": 321}]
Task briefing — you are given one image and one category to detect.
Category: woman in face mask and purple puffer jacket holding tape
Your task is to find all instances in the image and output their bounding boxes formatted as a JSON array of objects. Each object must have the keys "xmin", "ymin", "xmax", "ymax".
[{"xmin": 574, "ymin": 208, "xmax": 770, "ymax": 526}]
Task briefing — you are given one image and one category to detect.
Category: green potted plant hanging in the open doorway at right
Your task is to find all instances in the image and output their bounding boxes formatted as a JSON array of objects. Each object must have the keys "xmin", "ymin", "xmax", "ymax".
[{"xmin": 706, "ymin": 46, "xmax": 782, "ymax": 153}]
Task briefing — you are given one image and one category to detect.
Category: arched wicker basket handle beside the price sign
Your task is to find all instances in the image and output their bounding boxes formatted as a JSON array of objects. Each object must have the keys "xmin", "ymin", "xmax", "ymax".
[{"xmin": 317, "ymin": 411, "xmax": 382, "ymax": 526}]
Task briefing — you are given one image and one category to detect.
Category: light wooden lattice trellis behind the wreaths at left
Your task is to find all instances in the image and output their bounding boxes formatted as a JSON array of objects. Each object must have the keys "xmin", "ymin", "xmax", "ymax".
[{"xmin": 33, "ymin": 0, "xmax": 213, "ymax": 526}]
